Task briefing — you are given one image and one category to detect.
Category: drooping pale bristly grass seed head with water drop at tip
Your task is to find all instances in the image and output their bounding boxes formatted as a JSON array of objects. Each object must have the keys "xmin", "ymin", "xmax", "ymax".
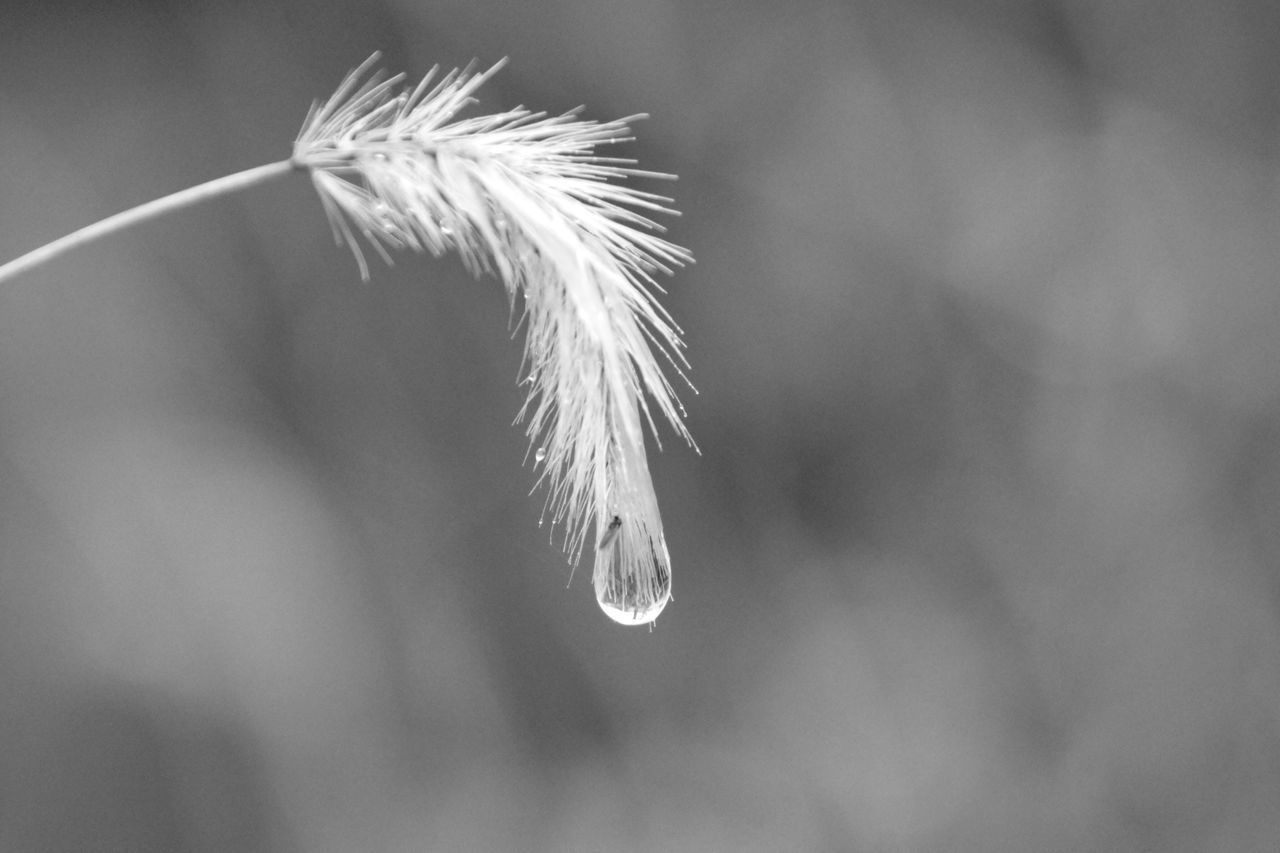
[{"xmin": 293, "ymin": 54, "xmax": 692, "ymax": 624}]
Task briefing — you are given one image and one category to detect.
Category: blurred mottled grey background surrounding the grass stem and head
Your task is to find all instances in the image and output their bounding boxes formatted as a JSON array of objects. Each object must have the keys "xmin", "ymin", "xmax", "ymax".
[{"xmin": 0, "ymin": 0, "xmax": 1280, "ymax": 853}]
